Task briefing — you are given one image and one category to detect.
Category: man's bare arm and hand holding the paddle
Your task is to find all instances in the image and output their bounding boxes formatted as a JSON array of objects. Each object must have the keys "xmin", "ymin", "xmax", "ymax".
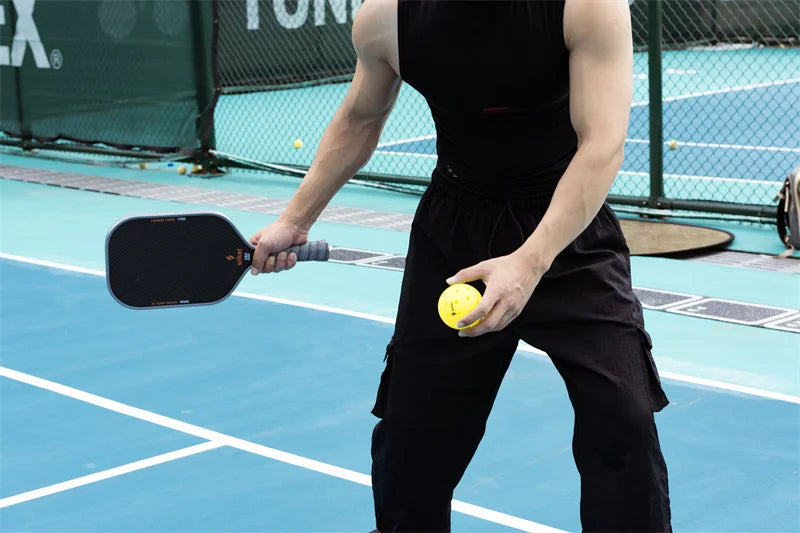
[{"xmin": 250, "ymin": 0, "xmax": 401, "ymax": 273}]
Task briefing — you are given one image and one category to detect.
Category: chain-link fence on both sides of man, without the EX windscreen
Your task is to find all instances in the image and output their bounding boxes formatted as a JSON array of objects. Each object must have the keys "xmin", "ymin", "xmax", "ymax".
[{"xmin": 216, "ymin": 0, "xmax": 800, "ymax": 216}]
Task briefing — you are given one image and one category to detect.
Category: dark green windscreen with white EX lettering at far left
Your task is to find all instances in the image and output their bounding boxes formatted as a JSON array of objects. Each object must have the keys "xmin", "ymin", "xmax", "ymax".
[{"xmin": 0, "ymin": 0, "xmax": 213, "ymax": 150}]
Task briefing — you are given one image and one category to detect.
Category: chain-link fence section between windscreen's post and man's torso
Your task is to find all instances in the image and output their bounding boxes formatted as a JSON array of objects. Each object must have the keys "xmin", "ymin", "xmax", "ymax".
[{"xmin": 215, "ymin": 0, "xmax": 435, "ymax": 188}]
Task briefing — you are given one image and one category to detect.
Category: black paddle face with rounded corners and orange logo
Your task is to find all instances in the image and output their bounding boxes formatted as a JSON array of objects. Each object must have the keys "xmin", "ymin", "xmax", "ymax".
[{"xmin": 106, "ymin": 213, "xmax": 253, "ymax": 308}]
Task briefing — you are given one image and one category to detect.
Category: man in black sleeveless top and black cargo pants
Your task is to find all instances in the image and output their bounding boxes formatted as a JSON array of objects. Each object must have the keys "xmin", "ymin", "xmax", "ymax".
[{"xmin": 251, "ymin": 0, "xmax": 670, "ymax": 532}]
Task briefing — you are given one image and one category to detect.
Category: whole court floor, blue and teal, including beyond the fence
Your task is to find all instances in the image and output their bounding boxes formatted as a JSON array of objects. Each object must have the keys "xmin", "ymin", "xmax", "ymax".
[{"xmin": 0, "ymin": 44, "xmax": 800, "ymax": 533}]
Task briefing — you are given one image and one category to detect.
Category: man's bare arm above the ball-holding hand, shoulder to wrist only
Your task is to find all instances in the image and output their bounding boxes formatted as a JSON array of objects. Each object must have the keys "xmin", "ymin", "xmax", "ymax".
[{"xmin": 520, "ymin": 0, "xmax": 633, "ymax": 272}]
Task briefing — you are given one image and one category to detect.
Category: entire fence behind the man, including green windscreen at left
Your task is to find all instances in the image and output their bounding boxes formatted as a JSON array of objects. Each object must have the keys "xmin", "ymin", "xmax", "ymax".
[{"xmin": 0, "ymin": 0, "xmax": 800, "ymax": 214}]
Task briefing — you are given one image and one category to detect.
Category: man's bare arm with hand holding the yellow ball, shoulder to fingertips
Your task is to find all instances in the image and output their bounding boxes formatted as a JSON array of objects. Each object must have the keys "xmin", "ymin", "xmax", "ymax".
[{"xmin": 447, "ymin": 0, "xmax": 633, "ymax": 337}]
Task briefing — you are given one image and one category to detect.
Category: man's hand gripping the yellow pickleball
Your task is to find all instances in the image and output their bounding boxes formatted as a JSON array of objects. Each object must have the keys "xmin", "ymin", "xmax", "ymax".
[{"xmin": 447, "ymin": 253, "xmax": 544, "ymax": 337}]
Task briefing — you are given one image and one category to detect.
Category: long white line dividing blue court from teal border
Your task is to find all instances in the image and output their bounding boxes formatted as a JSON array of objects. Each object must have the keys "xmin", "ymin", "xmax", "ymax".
[{"xmin": 0, "ymin": 252, "xmax": 800, "ymax": 402}]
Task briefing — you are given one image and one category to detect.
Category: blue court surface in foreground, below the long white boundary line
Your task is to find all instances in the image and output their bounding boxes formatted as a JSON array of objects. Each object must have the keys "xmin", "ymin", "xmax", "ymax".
[{"xmin": 0, "ymin": 255, "xmax": 800, "ymax": 532}]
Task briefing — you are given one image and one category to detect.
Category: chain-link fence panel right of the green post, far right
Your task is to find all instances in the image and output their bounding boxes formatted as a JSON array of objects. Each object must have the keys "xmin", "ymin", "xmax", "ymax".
[{"xmin": 663, "ymin": 0, "xmax": 800, "ymax": 210}]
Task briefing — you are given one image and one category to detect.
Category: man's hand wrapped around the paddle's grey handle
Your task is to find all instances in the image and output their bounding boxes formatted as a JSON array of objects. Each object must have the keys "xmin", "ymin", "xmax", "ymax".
[{"xmin": 250, "ymin": 218, "xmax": 308, "ymax": 276}]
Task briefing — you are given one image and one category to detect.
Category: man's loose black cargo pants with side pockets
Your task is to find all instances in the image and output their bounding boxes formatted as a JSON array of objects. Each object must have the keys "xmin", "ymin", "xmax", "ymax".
[{"xmin": 372, "ymin": 173, "xmax": 671, "ymax": 532}]
